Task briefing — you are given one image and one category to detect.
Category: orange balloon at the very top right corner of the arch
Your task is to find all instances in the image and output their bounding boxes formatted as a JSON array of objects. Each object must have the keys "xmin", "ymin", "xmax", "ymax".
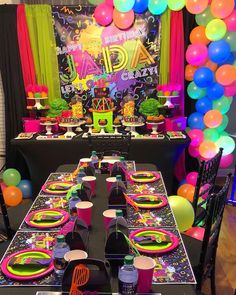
[{"xmin": 211, "ymin": 0, "xmax": 234, "ymax": 18}]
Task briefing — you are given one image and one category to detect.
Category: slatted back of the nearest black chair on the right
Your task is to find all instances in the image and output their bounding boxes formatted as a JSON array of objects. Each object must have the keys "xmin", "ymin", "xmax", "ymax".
[{"xmin": 197, "ymin": 174, "xmax": 231, "ymax": 290}]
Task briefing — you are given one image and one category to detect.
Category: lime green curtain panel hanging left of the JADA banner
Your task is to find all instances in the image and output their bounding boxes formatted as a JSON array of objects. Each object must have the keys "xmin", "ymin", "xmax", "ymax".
[{"xmin": 25, "ymin": 5, "xmax": 61, "ymax": 102}]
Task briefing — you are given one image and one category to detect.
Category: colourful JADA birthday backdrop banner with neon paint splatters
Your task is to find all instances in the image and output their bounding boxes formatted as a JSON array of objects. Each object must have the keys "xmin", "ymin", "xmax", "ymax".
[{"xmin": 52, "ymin": 5, "xmax": 161, "ymax": 110}]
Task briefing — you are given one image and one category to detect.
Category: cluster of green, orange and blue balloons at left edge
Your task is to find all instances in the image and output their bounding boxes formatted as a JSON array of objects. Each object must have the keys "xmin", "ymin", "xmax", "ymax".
[{"xmin": 1, "ymin": 168, "xmax": 32, "ymax": 206}]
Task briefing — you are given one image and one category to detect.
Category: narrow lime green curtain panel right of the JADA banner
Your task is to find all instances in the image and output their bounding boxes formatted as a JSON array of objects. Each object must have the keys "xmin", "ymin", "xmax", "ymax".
[{"xmin": 159, "ymin": 9, "xmax": 170, "ymax": 84}]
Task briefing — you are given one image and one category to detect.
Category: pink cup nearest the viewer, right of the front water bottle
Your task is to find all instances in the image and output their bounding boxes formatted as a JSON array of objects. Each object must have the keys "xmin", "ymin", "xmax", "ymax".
[{"xmin": 134, "ymin": 256, "xmax": 156, "ymax": 293}]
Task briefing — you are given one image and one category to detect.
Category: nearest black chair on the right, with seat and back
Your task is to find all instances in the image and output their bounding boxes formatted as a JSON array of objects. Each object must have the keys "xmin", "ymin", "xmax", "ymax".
[{"xmin": 182, "ymin": 174, "xmax": 231, "ymax": 295}]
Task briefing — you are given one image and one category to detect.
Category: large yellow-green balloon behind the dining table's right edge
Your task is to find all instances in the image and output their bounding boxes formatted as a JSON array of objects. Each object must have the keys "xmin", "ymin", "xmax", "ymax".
[{"xmin": 168, "ymin": 196, "xmax": 194, "ymax": 232}]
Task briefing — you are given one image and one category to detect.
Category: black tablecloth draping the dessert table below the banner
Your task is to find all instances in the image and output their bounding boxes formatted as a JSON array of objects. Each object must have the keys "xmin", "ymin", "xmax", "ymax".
[{"xmin": 11, "ymin": 137, "xmax": 190, "ymax": 195}]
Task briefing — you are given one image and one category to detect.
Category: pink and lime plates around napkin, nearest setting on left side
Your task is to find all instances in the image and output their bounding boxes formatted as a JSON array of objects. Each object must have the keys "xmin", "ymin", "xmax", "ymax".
[{"xmin": 1, "ymin": 249, "xmax": 54, "ymax": 281}]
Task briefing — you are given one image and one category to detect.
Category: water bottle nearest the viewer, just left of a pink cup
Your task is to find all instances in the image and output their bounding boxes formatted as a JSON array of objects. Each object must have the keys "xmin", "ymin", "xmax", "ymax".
[{"xmin": 118, "ymin": 255, "xmax": 138, "ymax": 295}]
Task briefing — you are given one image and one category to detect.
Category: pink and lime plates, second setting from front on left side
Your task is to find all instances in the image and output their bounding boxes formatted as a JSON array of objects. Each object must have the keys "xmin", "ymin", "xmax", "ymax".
[{"xmin": 25, "ymin": 209, "xmax": 70, "ymax": 228}]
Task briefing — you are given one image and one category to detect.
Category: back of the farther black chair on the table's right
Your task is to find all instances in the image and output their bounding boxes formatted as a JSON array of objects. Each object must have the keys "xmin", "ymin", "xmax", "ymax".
[{"xmin": 192, "ymin": 148, "xmax": 223, "ymax": 226}]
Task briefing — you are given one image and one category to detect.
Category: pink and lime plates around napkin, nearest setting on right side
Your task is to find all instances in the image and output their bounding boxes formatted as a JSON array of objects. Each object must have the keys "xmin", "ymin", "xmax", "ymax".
[{"xmin": 129, "ymin": 227, "xmax": 179, "ymax": 254}]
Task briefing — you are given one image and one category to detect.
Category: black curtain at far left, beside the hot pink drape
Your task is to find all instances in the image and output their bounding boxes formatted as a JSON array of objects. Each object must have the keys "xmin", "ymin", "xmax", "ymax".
[{"xmin": 0, "ymin": 5, "xmax": 27, "ymax": 177}]
